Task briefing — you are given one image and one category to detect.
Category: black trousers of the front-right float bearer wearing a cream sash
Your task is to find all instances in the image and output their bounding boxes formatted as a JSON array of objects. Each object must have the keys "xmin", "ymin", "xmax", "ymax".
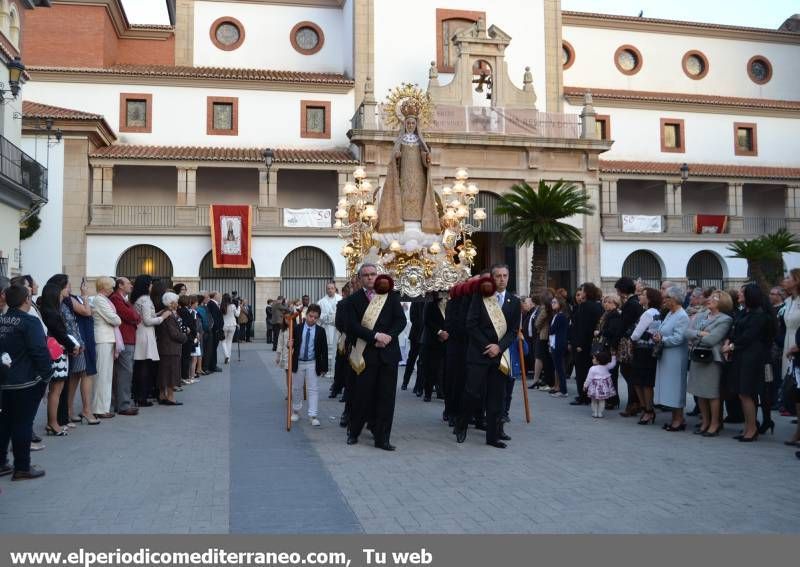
[{"xmin": 459, "ymin": 364, "xmax": 508, "ymax": 443}]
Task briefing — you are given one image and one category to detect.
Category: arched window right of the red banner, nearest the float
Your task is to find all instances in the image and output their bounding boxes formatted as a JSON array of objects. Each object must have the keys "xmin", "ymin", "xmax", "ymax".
[{"xmin": 281, "ymin": 246, "xmax": 334, "ymax": 303}]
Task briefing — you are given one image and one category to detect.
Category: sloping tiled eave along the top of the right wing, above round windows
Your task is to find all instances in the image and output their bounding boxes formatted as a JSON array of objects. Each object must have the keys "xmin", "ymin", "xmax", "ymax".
[{"xmin": 561, "ymin": 11, "xmax": 800, "ymax": 45}]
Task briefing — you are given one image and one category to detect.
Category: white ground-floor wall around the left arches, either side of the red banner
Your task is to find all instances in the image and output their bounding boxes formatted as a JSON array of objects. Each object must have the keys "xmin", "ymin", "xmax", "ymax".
[{"xmin": 86, "ymin": 234, "xmax": 346, "ymax": 278}]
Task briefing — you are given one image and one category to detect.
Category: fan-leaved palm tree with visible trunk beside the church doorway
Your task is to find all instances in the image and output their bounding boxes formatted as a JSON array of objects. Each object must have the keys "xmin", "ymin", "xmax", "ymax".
[{"xmin": 495, "ymin": 179, "xmax": 594, "ymax": 295}]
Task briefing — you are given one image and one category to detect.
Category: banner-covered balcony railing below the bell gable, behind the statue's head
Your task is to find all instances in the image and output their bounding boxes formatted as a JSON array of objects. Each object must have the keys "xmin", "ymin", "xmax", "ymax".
[{"xmin": 351, "ymin": 104, "xmax": 581, "ymax": 139}]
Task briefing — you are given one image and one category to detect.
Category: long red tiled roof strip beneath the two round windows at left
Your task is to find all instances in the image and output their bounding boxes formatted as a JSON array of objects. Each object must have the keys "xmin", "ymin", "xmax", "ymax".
[{"xmin": 28, "ymin": 65, "xmax": 355, "ymax": 86}]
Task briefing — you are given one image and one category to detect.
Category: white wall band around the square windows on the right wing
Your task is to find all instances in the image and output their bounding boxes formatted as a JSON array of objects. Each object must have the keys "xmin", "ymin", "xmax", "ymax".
[{"xmin": 564, "ymin": 103, "xmax": 800, "ymax": 167}]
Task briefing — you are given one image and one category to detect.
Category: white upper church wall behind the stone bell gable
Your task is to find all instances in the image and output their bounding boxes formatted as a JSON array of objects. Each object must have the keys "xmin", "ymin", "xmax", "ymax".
[{"xmin": 374, "ymin": 0, "xmax": 548, "ymax": 110}]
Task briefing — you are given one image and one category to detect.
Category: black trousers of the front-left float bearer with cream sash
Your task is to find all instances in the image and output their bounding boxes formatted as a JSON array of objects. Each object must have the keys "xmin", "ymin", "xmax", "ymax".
[{"xmin": 349, "ymin": 357, "xmax": 397, "ymax": 445}]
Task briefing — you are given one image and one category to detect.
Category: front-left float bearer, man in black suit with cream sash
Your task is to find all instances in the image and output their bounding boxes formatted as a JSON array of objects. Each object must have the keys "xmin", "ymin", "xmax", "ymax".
[{"xmin": 346, "ymin": 264, "xmax": 406, "ymax": 451}]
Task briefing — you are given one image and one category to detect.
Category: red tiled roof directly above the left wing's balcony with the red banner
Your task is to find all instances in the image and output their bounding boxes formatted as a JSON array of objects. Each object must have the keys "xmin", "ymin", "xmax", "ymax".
[{"xmin": 90, "ymin": 144, "xmax": 358, "ymax": 165}]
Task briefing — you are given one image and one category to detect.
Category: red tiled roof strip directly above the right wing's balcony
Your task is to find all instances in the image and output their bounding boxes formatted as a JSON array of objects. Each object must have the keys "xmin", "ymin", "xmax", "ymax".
[{"xmin": 600, "ymin": 159, "xmax": 800, "ymax": 179}]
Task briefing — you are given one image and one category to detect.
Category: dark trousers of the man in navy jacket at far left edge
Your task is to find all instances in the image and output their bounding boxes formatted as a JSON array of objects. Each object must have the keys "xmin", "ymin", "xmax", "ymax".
[{"xmin": 0, "ymin": 382, "xmax": 47, "ymax": 471}]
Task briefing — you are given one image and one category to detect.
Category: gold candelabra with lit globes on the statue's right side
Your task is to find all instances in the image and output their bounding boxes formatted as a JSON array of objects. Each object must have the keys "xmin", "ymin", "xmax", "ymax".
[{"xmin": 438, "ymin": 168, "xmax": 486, "ymax": 268}]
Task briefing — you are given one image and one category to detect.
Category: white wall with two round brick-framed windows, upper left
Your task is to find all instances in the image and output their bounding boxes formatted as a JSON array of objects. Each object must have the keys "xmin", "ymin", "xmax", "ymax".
[{"xmin": 194, "ymin": 2, "xmax": 347, "ymax": 73}]
